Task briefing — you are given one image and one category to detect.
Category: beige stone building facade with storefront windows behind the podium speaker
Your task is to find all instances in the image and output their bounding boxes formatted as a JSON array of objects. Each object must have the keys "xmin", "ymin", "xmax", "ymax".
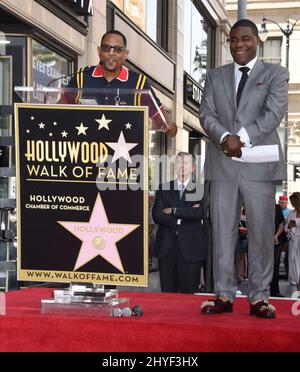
[{"xmin": 0, "ymin": 0, "xmax": 229, "ymax": 290}]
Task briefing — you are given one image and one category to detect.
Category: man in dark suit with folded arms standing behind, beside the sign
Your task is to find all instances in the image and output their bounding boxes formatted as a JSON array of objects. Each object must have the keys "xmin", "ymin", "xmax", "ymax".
[{"xmin": 152, "ymin": 152, "xmax": 206, "ymax": 293}]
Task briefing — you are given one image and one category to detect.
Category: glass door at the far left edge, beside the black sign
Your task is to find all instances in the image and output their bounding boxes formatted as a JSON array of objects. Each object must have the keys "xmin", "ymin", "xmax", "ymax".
[{"xmin": 0, "ymin": 56, "xmax": 17, "ymax": 291}]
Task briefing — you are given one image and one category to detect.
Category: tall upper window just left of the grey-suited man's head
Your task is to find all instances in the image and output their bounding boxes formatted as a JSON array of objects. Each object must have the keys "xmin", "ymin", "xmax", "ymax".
[{"xmin": 184, "ymin": 0, "xmax": 210, "ymax": 86}]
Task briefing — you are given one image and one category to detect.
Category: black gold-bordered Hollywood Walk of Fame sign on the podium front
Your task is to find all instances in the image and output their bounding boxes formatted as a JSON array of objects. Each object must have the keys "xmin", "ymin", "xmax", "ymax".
[{"xmin": 16, "ymin": 104, "xmax": 148, "ymax": 286}]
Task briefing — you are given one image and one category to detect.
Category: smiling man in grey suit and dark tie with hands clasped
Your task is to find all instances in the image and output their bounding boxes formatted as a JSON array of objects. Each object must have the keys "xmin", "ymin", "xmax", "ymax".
[{"xmin": 200, "ymin": 19, "xmax": 289, "ymax": 318}]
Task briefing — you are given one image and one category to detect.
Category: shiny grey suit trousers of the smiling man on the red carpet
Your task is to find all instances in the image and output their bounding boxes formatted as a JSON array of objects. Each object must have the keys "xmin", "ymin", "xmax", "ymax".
[{"xmin": 210, "ymin": 176, "xmax": 276, "ymax": 302}]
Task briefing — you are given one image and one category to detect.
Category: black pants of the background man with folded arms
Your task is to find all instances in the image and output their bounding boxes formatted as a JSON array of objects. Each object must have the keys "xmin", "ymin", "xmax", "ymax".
[{"xmin": 159, "ymin": 240, "xmax": 201, "ymax": 293}]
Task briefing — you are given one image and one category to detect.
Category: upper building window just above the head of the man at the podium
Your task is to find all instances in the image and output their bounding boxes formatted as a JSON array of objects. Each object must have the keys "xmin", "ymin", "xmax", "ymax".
[{"xmin": 112, "ymin": 0, "xmax": 163, "ymax": 44}]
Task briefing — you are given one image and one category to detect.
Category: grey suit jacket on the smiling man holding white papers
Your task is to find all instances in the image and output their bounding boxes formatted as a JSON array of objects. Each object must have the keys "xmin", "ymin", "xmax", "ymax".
[{"xmin": 200, "ymin": 60, "xmax": 289, "ymax": 181}]
